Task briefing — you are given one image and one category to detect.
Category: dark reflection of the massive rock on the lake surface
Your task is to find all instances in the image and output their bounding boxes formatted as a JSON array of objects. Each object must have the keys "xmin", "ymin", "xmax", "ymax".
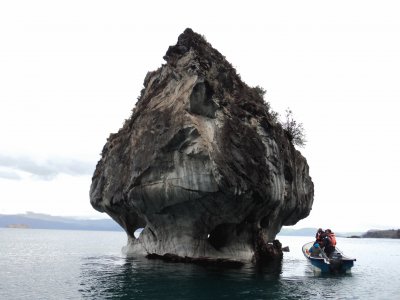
[{"xmin": 79, "ymin": 257, "xmax": 282, "ymax": 299}]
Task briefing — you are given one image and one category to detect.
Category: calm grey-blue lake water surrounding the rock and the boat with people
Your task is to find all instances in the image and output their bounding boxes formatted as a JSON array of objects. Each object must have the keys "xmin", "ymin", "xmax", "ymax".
[{"xmin": 0, "ymin": 228, "xmax": 400, "ymax": 300}]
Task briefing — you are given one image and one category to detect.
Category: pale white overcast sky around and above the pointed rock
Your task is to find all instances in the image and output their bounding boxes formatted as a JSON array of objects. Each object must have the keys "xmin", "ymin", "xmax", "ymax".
[{"xmin": 0, "ymin": 0, "xmax": 400, "ymax": 231}]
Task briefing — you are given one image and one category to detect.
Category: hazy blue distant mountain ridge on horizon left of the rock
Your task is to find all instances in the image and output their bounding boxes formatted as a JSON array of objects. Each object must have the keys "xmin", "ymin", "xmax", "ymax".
[{"xmin": 0, "ymin": 213, "xmax": 123, "ymax": 231}]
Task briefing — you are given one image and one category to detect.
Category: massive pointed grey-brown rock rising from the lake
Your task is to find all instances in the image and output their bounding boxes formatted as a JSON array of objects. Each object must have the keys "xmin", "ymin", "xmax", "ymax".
[{"xmin": 90, "ymin": 29, "xmax": 314, "ymax": 261}]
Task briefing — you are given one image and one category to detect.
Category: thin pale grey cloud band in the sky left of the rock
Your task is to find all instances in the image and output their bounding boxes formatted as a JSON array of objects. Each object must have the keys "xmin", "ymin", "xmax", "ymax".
[{"xmin": 0, "ymin": 154, "xmax": 95, "ymax": 180}]
